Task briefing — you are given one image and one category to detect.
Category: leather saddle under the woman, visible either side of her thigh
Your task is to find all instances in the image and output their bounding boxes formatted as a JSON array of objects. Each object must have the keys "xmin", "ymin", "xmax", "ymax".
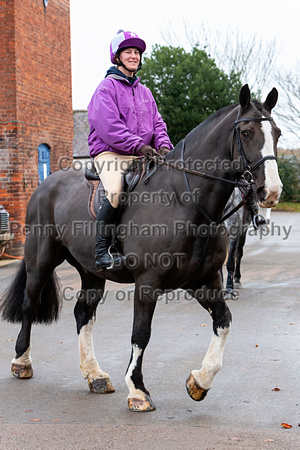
[{"xmin": 85, "ymin": 158, "xmax": 154, "ymax": 219}]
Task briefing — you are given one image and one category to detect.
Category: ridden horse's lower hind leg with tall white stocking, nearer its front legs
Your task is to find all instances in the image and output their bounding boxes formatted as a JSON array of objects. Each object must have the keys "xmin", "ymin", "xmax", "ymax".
[{"xmin": 74, "ymin": 272, "xmax": 115, "ymax": 394}]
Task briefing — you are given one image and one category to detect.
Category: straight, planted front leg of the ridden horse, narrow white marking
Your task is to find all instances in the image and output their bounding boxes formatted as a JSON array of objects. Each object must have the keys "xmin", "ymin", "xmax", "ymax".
[{"xmin": 125, "ymin": 285, "xmax": 156, "ymax": 412}]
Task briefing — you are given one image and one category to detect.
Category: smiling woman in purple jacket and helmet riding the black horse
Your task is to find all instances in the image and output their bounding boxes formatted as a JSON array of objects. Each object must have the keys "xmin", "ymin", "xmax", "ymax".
[{"xmin": 88, "ymin": 30, "xmax": 173, "ymax": 270}]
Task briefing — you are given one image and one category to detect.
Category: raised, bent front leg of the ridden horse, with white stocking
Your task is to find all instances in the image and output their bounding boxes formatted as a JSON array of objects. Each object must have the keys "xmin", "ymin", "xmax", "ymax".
[{"xmin": 186, "ymin": 276, "xmax": 231, "ymax": 401}]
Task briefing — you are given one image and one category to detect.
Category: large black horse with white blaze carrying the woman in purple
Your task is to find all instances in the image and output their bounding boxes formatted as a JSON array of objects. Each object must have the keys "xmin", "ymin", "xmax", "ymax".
[{"xmin": 1, "ymin": 85, "xmax": 282, "ymax": 411}]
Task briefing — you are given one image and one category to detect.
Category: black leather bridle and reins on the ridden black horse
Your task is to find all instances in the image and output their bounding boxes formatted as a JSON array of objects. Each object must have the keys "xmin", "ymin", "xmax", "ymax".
[{"xmin": 143, "ymin": 110, "xmax": 277, "ymax": 226}]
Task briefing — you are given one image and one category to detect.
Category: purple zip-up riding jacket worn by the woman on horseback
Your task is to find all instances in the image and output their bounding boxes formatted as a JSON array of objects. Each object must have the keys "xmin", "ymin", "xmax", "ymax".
[{"xmin": 88, "ymin": 68, "xmax": 173, "ymax": 158}]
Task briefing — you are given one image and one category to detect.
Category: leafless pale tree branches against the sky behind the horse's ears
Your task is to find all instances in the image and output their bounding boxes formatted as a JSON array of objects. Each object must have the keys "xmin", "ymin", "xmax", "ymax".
[{"xmin": 162, "ymin": 22, "xmax": 300, "ymax": 148}]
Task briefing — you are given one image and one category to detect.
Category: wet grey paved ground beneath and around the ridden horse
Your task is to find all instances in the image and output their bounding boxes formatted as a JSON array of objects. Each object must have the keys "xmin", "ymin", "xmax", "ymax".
[{"xmin": 0, "ymin": 212, "xmax": 300, "ymax": 450}]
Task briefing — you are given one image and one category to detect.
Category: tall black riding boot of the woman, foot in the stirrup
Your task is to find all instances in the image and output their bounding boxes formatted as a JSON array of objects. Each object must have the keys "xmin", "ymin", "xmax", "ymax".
[{"xmin": 95, "ymin": 198, "xmax": 125, "ymax": 270}]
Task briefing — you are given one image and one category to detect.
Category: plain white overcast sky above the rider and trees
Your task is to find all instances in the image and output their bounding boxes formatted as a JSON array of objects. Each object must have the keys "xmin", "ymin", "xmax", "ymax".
[{"xmin": 70, "ymin": 0, "xmax": 300, "ymax": 146}]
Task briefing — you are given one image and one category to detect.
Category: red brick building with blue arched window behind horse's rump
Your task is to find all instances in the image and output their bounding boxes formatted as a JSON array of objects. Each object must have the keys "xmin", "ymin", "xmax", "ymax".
[{"xmin": 0, "ymin": 0, "xmax": 73, "ymax": 255}]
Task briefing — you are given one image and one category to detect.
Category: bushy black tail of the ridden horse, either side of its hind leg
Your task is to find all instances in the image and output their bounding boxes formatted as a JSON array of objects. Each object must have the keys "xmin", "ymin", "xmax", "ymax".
[{"xmin": 0, "ymin": 260, "xmax": 61, "ymax": 323}]
